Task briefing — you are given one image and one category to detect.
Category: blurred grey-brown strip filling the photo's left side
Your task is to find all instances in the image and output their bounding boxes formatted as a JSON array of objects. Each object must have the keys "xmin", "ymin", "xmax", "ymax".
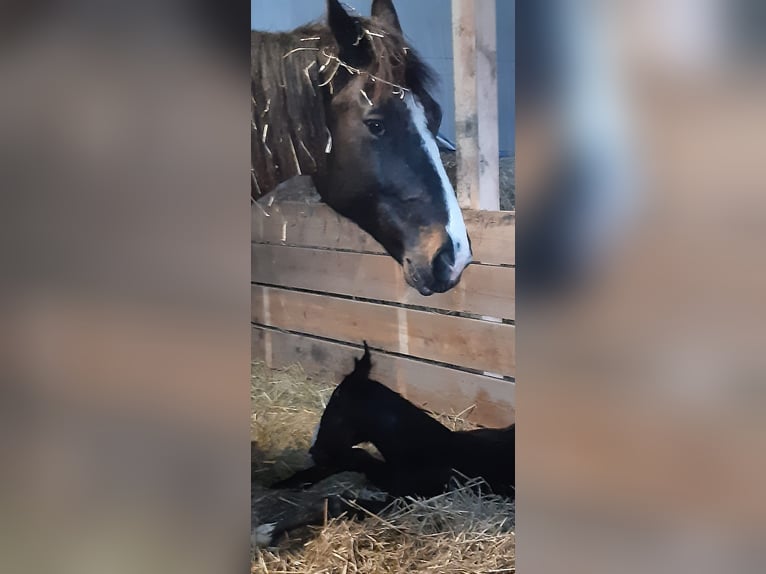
[{"xmin": 0, "ymin": 0, "xmax": 250, "ymax": 574}]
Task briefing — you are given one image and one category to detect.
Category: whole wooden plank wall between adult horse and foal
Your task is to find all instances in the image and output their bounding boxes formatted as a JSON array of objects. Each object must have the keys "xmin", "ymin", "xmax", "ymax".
[{"xmin": 251, "ymin": 202, "xmax": 515, "ymax": 426}]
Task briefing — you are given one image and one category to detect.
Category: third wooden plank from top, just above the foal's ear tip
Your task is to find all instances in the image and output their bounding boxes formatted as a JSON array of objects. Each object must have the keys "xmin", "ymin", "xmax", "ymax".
[{"xmin": 251, "ymin": 285, "xmax": 515, "ymax": 376}]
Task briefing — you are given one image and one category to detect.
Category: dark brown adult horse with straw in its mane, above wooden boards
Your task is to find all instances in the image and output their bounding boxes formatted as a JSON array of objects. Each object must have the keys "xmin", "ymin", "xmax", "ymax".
[{"xmin": 251, "ymin": 0, "xmax": 471, "ymax": 295}]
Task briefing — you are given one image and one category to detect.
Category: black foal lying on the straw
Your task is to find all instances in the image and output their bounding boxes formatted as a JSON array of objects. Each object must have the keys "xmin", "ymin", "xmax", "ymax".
[{"xmin": 282, "ymin": 343, "xmax": 515, "ymax": 496}]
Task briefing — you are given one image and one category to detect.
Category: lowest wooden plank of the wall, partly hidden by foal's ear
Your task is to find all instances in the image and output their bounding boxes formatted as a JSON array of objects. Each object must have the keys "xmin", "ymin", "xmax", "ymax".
[{"xmin": 252, "ymin": 326, "xmax": 516, "ymax": 427}]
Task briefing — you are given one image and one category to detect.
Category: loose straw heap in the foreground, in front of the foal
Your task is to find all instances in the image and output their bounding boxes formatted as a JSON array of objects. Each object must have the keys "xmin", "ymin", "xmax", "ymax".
[{"xmin": 252, "ymin": 484, "xmax": 516, "ymax": 574}]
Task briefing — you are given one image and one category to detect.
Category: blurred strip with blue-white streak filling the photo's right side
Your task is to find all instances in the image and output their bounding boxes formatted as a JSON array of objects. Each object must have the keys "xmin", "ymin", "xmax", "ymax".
[{"xmin": 516, "ymin": 0, "xmax": 766, "ymax": 572}]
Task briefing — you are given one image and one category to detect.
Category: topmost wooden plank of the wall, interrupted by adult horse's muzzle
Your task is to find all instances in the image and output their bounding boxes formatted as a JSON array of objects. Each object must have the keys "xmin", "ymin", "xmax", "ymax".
[{"xmin": 251, "ymin": 201, "xmax": 516, "ymax": 265}]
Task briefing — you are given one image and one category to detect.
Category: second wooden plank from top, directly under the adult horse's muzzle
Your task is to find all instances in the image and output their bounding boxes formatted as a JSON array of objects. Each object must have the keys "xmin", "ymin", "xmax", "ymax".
[{"xmin": 251, "ymin": 243, "xmax": 515, "ymax": 319}]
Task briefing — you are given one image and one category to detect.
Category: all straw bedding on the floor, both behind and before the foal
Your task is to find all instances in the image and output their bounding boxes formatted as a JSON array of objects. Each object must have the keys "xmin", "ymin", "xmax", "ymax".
[{"xmin": 251, "ymin": 363, "xmax": 515, "ymax": 574}]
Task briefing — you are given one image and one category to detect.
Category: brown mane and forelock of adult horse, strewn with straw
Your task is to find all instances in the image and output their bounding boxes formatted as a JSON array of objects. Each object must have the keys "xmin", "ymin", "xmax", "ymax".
[{"xmin": 250, "ymin": 17, "xmax": 435, "ymax": 199}]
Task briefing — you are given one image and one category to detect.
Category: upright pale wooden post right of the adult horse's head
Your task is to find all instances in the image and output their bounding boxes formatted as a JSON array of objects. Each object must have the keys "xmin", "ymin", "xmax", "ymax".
[{"xmin": 452, "ymin": 0, "xmax": 500, "ymax": 211}]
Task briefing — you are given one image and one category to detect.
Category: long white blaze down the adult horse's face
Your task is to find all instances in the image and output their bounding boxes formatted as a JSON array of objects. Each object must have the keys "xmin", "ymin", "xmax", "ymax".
[{"xmin": 404, "ymin": 93, "xmax": 471, "ymax": 281}]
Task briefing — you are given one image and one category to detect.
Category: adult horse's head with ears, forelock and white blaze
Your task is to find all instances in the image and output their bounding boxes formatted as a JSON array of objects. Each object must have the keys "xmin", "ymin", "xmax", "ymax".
[{"xmin": 317, "ymin": 0, "xmax": 471, "ymax": 295}]
